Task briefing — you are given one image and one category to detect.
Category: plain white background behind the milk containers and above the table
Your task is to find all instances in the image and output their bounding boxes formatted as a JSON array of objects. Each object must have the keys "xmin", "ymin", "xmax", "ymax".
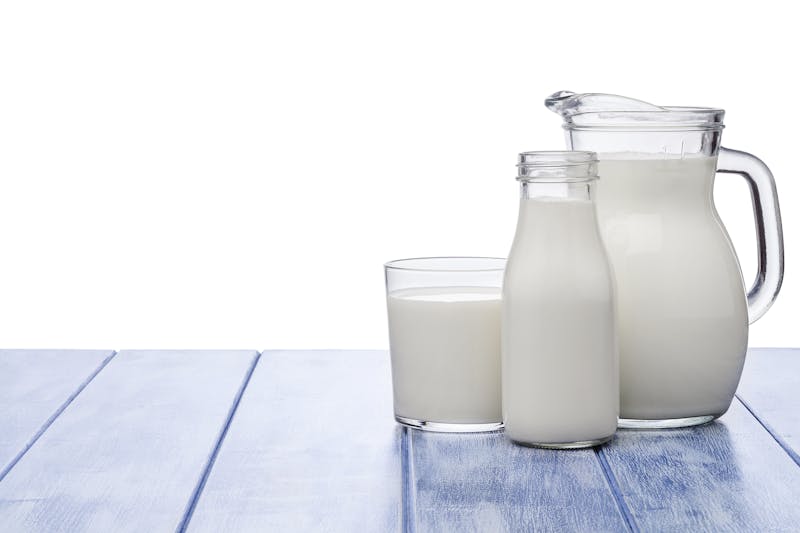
[{"xmin": 0, "ymin": 0, "xmax": 800, "ymax": 348}]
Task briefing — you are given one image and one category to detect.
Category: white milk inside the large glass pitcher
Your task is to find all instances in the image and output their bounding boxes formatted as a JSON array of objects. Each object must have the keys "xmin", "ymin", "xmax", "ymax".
[{"xmin": 597, "ymin": 155, "xmax": 748, "ymax": 420}]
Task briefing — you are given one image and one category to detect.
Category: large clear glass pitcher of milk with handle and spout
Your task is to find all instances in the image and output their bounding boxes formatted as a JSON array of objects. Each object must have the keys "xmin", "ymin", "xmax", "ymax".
[{"xmin": 545, "ymin": 91, "xmax": 783, "ymax": 428}]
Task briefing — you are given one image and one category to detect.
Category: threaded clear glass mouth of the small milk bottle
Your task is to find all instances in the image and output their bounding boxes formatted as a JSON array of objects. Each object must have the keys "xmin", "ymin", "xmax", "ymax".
[{"xmin": 517, "ymin": 150, "xmax": 597, "ymax": 182}]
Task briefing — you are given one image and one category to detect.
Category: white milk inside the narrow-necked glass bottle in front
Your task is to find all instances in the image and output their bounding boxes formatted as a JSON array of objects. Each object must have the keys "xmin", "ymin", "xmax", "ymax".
[{"xmin": 502, "ymin": 197, "xmax": 619, "ymax": 445}]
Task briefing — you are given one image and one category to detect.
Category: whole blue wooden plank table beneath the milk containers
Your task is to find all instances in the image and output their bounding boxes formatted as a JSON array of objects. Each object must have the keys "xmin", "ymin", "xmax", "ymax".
[{"xmin": 0, "ymin": 349, "xmax": 800, "ymax": 533}]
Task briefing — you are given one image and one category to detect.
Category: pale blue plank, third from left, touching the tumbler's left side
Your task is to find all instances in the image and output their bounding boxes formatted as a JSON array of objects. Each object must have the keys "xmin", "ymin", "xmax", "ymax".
[{"xmin": 188, "ymin": 351, "xmax": 402, "ymax": 532}]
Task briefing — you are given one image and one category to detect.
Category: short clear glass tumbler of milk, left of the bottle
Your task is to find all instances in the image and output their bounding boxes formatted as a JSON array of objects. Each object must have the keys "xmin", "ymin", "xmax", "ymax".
[{"xmin": 384, "ymin": 257, "xmax": 505, "ymax": 432}]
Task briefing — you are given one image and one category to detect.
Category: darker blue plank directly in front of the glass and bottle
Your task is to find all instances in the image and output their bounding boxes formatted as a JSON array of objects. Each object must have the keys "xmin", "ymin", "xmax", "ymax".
[{"xmin": 407, "ymin": 431, "xmax": 628, "ymax": 532}]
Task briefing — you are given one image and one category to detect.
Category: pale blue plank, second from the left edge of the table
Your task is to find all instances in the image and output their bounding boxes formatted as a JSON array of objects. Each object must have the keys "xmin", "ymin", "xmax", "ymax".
[{"xmin": 0, "ymin": 351, "xmax": 257, "ymax": 532}]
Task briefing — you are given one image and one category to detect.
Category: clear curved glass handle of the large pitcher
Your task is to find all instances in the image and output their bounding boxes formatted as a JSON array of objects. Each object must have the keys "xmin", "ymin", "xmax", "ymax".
[{"xmin": 717, "ymin": 147, "xmax": 783, "ymax": 324}]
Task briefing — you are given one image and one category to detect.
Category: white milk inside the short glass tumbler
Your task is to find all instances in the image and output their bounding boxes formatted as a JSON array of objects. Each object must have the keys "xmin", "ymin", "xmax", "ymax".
[{"xmin": 387, "ymin": 287, "xmax": 502, "ymax": 424}]
